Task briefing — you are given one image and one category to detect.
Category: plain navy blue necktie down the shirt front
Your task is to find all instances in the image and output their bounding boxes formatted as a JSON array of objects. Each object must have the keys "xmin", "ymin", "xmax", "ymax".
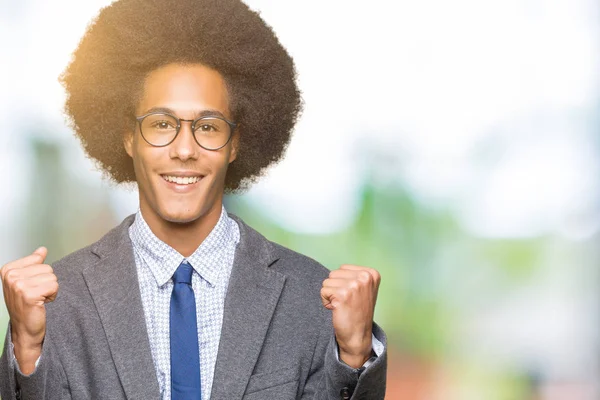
[{"xmin": 169, "ymin": 261, "xmax": 202, "ymax": 400}]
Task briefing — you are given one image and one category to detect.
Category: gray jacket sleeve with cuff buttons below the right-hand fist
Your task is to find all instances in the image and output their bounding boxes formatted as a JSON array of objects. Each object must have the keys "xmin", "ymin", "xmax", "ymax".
[{"xmin": 302, "ymin": 324, "xmax": 387, "ymax": 400}]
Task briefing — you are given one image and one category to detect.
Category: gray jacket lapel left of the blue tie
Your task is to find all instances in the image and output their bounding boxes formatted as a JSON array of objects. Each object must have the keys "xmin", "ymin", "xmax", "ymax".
[{"xmin": 83, "ymin": 216, "xmax": 160, "ymax": 399}]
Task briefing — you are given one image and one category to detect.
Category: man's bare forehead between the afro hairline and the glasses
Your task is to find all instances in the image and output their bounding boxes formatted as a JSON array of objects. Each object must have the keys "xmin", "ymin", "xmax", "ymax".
[{"xmin": 136, "ymin": 64, "xmax": 231, "ymax": 118}]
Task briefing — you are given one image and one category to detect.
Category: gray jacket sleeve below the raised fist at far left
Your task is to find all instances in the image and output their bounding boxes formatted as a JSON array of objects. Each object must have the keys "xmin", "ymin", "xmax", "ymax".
[{"xmin": 0, "ymin": 323, "xmax": 71, "ymax": 400}]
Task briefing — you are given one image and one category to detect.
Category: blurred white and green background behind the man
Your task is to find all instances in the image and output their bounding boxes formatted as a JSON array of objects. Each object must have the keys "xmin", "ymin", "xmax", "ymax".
[{"xmin": 0, "ymin": 0, "xmax": 600, "ymax": 400}]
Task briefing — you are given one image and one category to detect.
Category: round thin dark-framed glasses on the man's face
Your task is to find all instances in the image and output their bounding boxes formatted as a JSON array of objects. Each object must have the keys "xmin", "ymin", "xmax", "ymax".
[{"xmin": 135, "ymin": 113, "xmax": 237, "ymax": 150}]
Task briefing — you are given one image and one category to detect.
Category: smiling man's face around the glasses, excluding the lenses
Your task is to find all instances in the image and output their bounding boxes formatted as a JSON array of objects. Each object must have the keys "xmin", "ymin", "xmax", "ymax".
[{"xmin": 124, "ymin": 64, "xmax": 238, "ymax": 226}]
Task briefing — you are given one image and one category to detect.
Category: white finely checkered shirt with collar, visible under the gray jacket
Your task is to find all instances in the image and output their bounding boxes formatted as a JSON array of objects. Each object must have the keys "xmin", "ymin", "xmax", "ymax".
[{"xmin": 129, "ymin": 208, "xmax": 240, "ymax": 400}]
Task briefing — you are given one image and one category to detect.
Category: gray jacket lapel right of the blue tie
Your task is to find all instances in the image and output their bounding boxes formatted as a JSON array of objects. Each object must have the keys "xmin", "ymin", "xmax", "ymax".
[{"xmin": 211, "ymin": 219, "xmax": 285, "ymax": 400}]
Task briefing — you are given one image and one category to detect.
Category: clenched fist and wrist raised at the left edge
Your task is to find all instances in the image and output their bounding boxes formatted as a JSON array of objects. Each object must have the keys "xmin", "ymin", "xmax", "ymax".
[{"xmin": 0, "ymin": 247, "xmax": 58, "ymax": 374}]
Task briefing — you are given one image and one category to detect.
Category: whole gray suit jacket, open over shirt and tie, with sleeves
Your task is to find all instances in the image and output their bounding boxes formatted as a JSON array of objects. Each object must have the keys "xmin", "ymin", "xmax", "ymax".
[{"xmin": 0, "ymin": 216, "xmax": 387, "ymax": 400}]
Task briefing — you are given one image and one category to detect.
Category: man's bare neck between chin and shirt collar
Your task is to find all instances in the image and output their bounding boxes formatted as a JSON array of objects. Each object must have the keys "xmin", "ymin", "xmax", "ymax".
[{"xmin": 140, "ymin": 204, "xmax": 221, "ymax": 257}]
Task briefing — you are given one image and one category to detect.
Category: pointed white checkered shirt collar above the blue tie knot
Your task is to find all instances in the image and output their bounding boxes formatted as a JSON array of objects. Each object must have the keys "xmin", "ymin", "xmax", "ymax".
[{"xmin": 129, "ymin": 207, "xmax": 239, "ymax": 286}]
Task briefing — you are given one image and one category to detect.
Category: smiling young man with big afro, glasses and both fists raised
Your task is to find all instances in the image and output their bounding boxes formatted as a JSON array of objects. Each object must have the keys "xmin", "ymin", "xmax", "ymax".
[{"xmin": 0, "ymin": 0, "xmax": 386, "ymax": 400}]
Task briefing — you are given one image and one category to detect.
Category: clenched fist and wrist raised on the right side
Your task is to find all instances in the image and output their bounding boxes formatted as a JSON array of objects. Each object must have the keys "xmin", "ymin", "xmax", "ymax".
[{"xmin": 321, "ymin": 265, "xmax": 381, "ymax": 368}]
